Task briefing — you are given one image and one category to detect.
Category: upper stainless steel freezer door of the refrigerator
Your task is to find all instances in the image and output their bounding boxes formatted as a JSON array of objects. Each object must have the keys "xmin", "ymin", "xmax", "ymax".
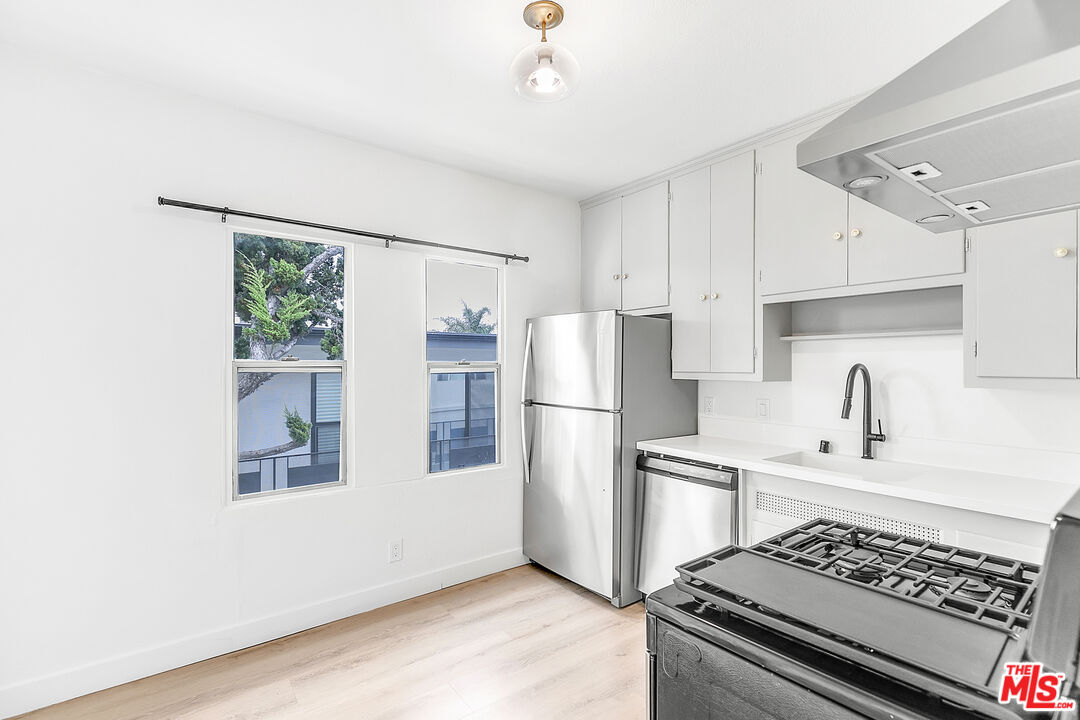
[{"xmin": 522, "ymin": 311, "xmax": 622, "ymax": 410}]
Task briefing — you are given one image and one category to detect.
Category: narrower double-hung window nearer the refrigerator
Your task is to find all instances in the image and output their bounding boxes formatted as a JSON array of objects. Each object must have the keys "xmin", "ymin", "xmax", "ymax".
[{"xmin": 426, "ymin": 259, "xmax": 501, "ymax": 473}]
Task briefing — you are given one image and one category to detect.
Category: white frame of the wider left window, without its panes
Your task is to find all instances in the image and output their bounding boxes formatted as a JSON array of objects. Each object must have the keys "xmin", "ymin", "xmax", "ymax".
[{"xmin": 225, "ymin": 225, "xmax": 353, "ymax": 505}]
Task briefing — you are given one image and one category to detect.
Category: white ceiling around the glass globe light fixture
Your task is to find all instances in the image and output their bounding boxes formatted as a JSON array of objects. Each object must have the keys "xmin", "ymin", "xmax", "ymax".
[{"xmin": 0, "ymin": 0, "xmax": 1003, "ymax": 199}]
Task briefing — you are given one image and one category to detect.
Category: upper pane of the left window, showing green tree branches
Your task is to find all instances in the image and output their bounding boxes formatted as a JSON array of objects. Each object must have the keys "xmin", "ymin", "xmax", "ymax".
[{"xmin": 232, "ymin": 232, "xmax": 345, "ymax": 361}]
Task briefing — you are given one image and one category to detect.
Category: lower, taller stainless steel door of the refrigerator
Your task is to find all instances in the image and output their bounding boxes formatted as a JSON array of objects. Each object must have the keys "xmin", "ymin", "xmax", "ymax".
[{"xmin": 524, "ymin": 405, "xmax": 621, "ymax": 598}]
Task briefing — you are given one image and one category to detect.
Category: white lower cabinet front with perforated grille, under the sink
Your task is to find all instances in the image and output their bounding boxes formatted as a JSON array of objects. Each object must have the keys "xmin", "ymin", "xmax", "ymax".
[{"xmin": 740, "ymin": 473, "xmax": 1050, "ymax": 565}]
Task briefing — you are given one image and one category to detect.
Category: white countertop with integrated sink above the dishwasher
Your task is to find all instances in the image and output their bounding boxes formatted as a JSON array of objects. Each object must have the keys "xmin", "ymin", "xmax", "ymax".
[{"xmin": 637, "ymin": 435, "xmax": 1078, "ymax": 525}]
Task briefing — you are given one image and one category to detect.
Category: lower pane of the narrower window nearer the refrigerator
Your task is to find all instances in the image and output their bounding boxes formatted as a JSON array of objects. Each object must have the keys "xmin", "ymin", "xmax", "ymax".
[{"xmin": 430, "ymin": 372, "xmax": 498, "ymax": 473}]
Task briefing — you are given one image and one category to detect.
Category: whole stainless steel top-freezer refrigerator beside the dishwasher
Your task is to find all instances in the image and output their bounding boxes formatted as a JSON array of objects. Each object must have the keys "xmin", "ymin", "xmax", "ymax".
[{"xmin": 522, "ymin": 311, "xmax": 698, "ymax": 607}]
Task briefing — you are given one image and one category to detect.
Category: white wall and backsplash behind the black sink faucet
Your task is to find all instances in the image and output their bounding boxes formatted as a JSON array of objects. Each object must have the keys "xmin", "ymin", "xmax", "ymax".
[{"xmin": 698, "ymin": 336, "xmax": 1080, "ymax": 483}]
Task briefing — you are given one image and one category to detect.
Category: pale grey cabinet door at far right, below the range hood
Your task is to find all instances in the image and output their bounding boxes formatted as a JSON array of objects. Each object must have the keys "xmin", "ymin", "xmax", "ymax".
[{"xmin": 968, "ymin": 213, "xmax": 1077, "ymax": 378}]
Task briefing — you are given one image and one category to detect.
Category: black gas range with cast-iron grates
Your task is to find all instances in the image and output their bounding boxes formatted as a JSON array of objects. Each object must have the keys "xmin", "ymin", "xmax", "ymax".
[{"xmin": 646, "ymin": 515, "xmax": 1080, "ymax": 720}]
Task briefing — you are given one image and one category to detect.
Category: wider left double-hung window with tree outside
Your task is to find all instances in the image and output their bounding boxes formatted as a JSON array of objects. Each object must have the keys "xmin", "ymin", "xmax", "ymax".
[{"xmin": 232, "ymin": 232, "xmax": 346, "ymax": 500}]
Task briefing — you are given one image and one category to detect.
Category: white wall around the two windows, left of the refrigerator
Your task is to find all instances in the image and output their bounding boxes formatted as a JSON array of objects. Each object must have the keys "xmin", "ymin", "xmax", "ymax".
[{"xmin": 0, "ymin": 46, "xmax": 579, "ymax": 717}]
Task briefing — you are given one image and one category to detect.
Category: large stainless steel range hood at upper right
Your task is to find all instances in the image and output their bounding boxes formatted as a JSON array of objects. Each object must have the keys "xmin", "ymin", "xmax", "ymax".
[{"xmin": 797, "ymin": 0, "xmax": 1080, "ymax": 232}]
